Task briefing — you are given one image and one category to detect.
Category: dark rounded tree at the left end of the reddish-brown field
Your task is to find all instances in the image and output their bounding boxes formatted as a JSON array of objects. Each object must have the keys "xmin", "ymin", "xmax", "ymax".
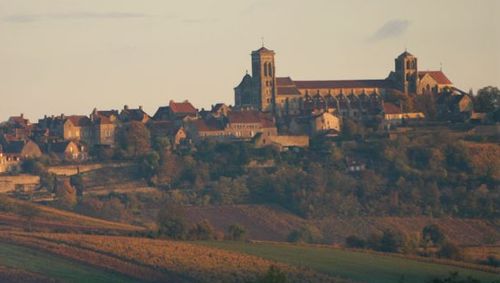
[{"xmin": 157, "ymin": 203, "xmax": 187, "ymax": 240}]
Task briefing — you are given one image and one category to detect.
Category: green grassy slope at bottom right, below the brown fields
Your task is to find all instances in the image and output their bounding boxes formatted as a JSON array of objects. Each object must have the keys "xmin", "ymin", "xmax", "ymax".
[{"xmin": 202, "ymin": 242, "xmax": 498, "ymax": 283}]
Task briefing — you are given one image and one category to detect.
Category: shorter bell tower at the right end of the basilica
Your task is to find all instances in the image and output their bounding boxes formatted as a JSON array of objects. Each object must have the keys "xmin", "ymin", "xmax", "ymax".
[{"xmin": 395, "ymin": 51, "xmax": 418, "ymax": 94}]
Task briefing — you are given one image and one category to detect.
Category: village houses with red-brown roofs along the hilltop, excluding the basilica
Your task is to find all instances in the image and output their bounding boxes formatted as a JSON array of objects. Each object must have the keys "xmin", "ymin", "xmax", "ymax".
[{"xmin": 0, "ymin": 89, "xmax": 472, "ymax": 171}]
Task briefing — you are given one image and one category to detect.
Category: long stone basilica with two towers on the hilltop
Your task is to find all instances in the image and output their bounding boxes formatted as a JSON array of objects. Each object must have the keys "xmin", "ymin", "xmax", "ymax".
[{"xmin": 234, "ymin": 47, "xmax": 453, "ymax": 118}]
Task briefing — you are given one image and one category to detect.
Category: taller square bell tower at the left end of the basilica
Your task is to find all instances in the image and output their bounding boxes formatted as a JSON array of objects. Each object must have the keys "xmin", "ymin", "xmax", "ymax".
[{"xmin": 252, "ymin": 46, "xmax": 276, "ymax": 112}]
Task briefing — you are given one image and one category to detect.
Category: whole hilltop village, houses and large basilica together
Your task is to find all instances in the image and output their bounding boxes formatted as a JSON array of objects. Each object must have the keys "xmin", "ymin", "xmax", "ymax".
[{"xmin": 0, "ymin": 47, "xmax": 492, "ymax": 172}]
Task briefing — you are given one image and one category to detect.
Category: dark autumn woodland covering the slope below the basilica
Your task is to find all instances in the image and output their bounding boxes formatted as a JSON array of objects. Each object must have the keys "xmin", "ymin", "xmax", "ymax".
[{"xmin": 123, "ymin": 125, "xmax": 500, "ymax": 221}]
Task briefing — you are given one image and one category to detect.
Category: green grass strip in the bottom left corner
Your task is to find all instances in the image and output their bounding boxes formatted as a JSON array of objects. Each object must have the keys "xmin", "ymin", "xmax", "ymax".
[{"xmin": 0, "ymin": 243, "xmax": 135, "ymax": 283}]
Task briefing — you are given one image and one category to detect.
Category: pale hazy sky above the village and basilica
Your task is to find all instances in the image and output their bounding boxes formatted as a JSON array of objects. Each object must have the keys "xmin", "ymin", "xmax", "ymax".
[{"xmin": 0, "ymin": 0, "xmax": 500, "ymax": 120}]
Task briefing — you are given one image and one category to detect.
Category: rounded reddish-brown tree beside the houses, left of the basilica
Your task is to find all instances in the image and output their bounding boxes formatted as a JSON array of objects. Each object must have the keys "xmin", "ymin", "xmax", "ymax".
[{"xmin": 117, "ymin": 121, "xmax": 151, "ymax": 158}]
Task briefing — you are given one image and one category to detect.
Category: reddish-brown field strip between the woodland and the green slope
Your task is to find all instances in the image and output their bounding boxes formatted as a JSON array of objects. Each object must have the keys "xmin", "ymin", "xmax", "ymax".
[{"xmin": 186, "ymin": 205, "xmax": 500, "ymax": 245}]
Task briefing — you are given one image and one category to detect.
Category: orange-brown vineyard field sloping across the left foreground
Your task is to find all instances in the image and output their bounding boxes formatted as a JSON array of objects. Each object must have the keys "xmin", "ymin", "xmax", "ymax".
[{"xmin": 0, "ymin": 232, "xmax": 344, "ymax": 283}]
